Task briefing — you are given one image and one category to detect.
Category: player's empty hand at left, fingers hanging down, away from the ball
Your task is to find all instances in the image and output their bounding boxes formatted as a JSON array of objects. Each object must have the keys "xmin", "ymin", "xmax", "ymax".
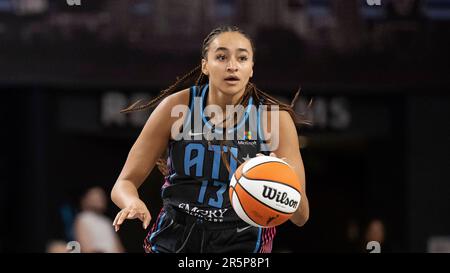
[{"xmin": 113, "ymin": 198, "xmax": 152, "ymax": 232}]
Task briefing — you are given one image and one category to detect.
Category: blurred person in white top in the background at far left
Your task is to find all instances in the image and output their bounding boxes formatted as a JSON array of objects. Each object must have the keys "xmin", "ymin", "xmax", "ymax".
[{"xmin": 74, "ymin": 187, "xmax": 124, "ymax": 253}]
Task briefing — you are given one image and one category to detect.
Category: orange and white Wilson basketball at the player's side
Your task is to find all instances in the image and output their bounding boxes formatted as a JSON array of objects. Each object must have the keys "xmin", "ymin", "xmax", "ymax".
[{"xmin": 229, "ymin": 156, "xmax": 301, "ymax": 227}]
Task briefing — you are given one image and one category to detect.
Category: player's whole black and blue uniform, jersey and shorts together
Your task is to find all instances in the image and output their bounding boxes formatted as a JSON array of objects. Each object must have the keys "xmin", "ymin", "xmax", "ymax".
[{"xmin": 144, "ymin": 85, "xmax": 276, "ymax": 253}]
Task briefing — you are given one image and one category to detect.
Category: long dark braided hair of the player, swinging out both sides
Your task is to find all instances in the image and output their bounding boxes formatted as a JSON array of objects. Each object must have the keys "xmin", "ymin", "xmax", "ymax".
[{"xmin": 121, "ymin": 26, "xmax": 310, "ymax": 175}]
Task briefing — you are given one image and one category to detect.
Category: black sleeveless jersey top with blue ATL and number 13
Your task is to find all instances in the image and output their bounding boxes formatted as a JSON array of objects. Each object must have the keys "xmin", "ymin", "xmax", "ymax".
[{"xmin": 161, "ymin": 85, "xmax": 267, "ymax": 222}]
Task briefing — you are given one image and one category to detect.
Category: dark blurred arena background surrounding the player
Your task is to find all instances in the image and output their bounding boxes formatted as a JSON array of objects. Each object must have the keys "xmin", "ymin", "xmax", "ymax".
[{"xmin": 0, "ymin": 0, "xmax": 450, "ymax": 252}]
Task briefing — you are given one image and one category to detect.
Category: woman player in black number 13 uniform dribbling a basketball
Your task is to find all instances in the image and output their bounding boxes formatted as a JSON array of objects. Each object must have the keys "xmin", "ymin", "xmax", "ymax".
[{"xmin": 111, "ymin": 27, "xmax": 309, "ymax": 253}]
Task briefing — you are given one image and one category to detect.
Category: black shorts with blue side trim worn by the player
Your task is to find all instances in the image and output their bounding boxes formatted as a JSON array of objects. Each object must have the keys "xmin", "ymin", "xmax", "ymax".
[{"xmin": 144, "ymin": 208, "xmax": 276, "ymax": 253}]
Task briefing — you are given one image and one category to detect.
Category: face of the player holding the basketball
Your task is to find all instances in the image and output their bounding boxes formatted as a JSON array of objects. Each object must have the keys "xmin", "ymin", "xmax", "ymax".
[{"xmin": 202, "ymin": 32, "xmax": 253, "ymax": 95}]
